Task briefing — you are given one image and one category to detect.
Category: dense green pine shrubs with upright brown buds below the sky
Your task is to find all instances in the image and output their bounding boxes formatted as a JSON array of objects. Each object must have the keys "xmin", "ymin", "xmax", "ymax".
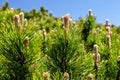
[{"xmin": 0, "ymin": 3, "xmax": 120, "ymax": 80}]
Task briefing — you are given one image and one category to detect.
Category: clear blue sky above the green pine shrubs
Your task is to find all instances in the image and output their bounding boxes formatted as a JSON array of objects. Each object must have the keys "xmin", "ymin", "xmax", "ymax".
[{"xmin": 0, "ymin": 0, "xmax": 120, "ymax": 26}]
